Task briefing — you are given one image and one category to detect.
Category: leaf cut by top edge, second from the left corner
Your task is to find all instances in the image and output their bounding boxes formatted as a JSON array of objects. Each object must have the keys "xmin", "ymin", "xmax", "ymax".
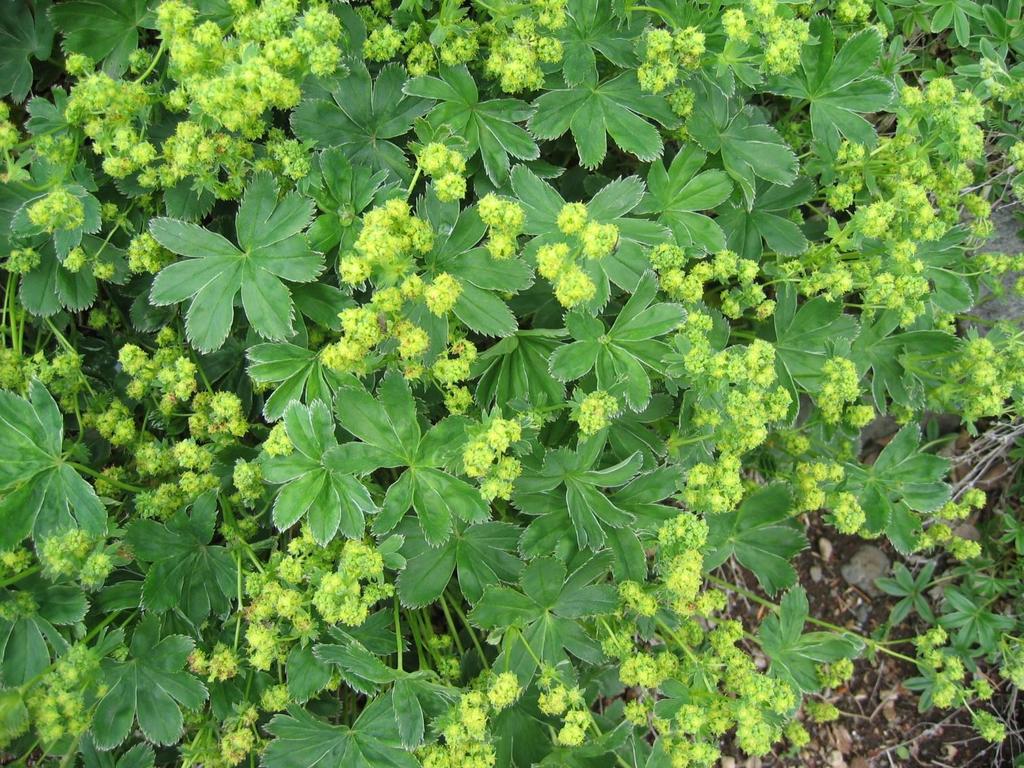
[{"xmin": 50, "ymin": 0, "xmax": 151, "ymax": 75}]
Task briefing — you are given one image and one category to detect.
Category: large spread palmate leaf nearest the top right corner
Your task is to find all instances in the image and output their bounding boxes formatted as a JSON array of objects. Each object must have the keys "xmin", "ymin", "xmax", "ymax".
[{"xmin": 771, "ymin": 16, "xmax": 895, "ymax": 153}]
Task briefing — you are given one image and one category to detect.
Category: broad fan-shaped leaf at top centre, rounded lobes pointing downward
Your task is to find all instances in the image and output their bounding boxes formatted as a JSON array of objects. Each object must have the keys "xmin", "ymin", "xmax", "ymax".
[{"xmin": 529, "ymin": 72, "xmax": 679, "ymax": 168}]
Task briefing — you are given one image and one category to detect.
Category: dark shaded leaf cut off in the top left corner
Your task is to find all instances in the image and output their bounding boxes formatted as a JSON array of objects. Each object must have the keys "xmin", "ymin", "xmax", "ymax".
[{"xmin": 0, "ymin": 0, "xmax": 53, "ymax": 103}]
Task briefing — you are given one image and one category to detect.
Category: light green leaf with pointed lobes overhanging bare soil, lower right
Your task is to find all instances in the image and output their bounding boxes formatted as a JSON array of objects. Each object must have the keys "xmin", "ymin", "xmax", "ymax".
[{"xmin": 758, "ymin": 587, "xmax": 862, "ymax": 692}]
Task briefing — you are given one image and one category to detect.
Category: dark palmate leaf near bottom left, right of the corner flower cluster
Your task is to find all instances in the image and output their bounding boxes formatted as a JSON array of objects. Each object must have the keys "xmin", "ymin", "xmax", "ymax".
[{"xmin": 92, "ymin": 615, "xmax": 207, "ymax": 750}]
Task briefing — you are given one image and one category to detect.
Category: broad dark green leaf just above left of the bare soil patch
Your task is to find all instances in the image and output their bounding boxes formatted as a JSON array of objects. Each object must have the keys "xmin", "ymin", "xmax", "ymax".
[{"xmin": 705, "ymin": 485, "xmax": 807, "ymax": 595}]
